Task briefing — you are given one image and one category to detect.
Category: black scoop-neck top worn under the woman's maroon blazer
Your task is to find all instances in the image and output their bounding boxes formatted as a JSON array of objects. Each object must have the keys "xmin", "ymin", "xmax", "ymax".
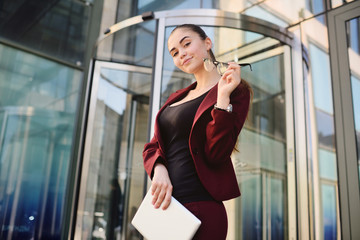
[{"xmin": 159, "ymin": 92, "xmax": 213, "ymax": 203}]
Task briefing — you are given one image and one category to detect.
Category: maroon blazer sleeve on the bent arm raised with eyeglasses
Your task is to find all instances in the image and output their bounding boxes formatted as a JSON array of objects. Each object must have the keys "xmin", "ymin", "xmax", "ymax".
[{"xmin": 204, "ymin": 84, "xmax": 250, "ymax": 166}]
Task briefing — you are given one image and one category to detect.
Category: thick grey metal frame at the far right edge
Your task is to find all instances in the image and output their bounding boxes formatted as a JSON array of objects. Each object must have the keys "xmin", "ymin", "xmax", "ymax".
[{"xmin": 328, "ymin": 1, "xmax": 360, "ymax": 239}]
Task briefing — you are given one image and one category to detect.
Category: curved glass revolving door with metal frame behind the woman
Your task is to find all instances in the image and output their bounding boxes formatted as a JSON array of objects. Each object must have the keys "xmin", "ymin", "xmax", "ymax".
[{"xmin": 75, "ymin": 9, "xmax": 296, "ymax": 239}]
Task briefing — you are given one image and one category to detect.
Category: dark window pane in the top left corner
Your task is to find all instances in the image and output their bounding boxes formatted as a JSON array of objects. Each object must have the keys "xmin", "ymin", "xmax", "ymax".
[{"xmin": 0, "ymin": 0, "xmax": 90, "ymax": 65}]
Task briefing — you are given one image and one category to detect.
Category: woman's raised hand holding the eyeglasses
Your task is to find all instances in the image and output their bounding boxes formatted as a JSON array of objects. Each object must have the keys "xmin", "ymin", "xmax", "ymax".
[{"xmin": 218, "ymin": 62, "xmax": 241, "ymax": 97}]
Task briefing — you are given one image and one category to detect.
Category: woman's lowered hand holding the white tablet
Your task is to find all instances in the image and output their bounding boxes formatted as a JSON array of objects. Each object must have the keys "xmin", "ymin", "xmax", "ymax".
[{"xmin": 151, "ymin": 163, "xmax": 173, "ymax": 210}]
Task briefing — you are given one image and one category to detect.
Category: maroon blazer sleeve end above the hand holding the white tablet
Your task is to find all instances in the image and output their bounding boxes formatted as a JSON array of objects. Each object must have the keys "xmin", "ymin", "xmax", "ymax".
[{"xmin": 143, "ymin": 136, "xmax": 166, "ymax": 179}]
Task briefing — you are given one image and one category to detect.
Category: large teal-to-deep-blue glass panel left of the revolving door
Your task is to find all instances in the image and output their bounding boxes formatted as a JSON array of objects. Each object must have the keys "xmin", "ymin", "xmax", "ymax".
[{"xmin": 0, "ymin": 45, "xmax": 82, "ymax": 239}]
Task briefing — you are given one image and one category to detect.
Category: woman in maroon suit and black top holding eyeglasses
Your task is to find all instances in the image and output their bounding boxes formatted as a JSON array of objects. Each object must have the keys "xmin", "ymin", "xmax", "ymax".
[{"xmin": 143, "ymin": 24, "xmax": 252, "ymax": 240}]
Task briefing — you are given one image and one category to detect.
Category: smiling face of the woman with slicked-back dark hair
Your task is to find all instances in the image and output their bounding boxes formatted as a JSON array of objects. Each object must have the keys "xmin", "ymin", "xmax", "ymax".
[{"xmin": 168, "ymin": 28, "xmax": 211, "ymax": 74}]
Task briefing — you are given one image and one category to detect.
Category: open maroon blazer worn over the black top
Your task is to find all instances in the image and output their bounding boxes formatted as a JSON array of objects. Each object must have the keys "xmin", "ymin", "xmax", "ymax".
[{"xmin": 143, "ymin": 82, "xmax": 250, "ymax": 201}]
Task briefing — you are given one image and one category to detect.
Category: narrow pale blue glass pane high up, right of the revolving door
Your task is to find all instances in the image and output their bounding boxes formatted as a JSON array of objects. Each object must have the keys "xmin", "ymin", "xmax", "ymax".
[{"xmin": 309, "ymin": 44, "xmax": 333, "ymax": 114}]
